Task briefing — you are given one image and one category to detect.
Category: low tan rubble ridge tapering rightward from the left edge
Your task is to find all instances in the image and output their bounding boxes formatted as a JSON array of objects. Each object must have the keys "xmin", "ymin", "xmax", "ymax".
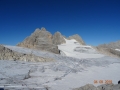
[{"xmin": 0, "ymin": 45, "xmax": 54, "ymax": 62}]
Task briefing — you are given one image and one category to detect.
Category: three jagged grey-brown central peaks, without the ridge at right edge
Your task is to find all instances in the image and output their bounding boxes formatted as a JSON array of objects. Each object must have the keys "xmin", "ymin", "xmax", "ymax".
[{"xmin": 17, "ymin": 27, "xmax": 85, "ymax": 54}]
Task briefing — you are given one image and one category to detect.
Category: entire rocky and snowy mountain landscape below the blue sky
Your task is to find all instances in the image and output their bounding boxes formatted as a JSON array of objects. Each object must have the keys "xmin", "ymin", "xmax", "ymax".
[{"xmin": 0, "ymin": 28, "xmax": 120, "ymax": 90}]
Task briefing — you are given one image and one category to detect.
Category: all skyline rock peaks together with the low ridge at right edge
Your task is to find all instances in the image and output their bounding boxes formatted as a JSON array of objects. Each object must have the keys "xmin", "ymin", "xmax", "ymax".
[{"xmin": 17, "ymin": 27, "xmax": 120, "ymax": 57}]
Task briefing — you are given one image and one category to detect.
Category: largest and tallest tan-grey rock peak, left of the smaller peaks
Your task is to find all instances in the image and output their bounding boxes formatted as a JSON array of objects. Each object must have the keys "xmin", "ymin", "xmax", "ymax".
[{"xmin": 18, "ymin": 28, "xmax": 59, "ymax": 54}]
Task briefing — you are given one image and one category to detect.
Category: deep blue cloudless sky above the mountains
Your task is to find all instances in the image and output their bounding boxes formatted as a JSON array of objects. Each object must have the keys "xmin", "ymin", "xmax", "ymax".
[{"xmin": 0, "ymin": 0, "xmax": 120, "ymax": 46}]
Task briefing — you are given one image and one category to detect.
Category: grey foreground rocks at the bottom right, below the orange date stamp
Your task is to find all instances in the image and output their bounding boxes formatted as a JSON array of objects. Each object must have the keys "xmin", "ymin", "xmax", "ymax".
[{"xmin": 73, "ymin": 84, "xmax": 120, "ymax": 90}]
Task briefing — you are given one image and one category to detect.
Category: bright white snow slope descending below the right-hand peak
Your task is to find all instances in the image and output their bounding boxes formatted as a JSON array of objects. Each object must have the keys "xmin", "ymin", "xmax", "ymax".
[{"xmin": 58, "ymin": 39, "xmax": 104, "ymax": 59}]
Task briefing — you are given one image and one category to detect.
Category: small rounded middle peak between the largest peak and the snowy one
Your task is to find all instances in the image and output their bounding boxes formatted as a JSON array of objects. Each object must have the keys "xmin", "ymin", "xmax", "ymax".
[{"xmin": 52, "ymin": 32, "xmax": 66, "ymax": 45}]
